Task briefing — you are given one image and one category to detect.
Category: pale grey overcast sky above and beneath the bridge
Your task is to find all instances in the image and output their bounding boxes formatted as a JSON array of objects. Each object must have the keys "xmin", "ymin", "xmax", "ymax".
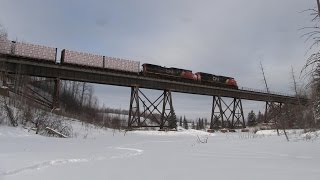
[{"xmin": 0, "ymin": 0, "xmax": 316, "ymax": 117}]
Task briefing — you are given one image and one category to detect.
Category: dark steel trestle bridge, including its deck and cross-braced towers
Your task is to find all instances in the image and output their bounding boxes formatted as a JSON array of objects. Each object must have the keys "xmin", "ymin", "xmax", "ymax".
[{"xmin": 0, "ymin": 54, "xmax": 307, "ymax": 129}]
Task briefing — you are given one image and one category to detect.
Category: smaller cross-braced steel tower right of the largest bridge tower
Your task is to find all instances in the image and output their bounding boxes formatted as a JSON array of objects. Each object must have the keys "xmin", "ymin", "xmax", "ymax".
[{"xmin": 210, "ymin": 96, "xmax": 246, "ymax": 129}]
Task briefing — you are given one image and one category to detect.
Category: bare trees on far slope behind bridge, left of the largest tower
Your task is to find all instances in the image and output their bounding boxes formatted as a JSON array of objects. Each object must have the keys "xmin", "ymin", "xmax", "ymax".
[{"xmin": 34, "ymin": 81, "xmax": 128, "ymax": 129}]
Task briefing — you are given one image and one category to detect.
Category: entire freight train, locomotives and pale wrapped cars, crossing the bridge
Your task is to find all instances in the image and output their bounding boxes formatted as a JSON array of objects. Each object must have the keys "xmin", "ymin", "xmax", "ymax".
[{"xmin": 0, "ymin": 39, "xmax": 238, "ymax": 89}]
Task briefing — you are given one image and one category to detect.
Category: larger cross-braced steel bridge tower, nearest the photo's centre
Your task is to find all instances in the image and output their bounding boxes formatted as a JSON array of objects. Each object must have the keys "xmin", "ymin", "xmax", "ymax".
[{"xmin": 128, "ymin": 87, "xmax": 174, "ymax": 130}]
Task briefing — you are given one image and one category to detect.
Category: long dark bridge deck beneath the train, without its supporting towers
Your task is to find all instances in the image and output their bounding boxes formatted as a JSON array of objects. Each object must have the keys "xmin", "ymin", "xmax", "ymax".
[{"xmin": 0, "ymin": 54, "xmax": 307, "ymax": 104}]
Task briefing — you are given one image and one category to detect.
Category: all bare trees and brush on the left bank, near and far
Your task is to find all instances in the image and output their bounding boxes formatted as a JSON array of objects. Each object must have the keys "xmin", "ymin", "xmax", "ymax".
[{"xmin": 0, "ymin": 73, "xmax": 128, "ymax": 131}]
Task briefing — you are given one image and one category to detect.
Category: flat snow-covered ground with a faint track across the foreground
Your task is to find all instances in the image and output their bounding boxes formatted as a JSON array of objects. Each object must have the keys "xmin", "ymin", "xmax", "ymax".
[{"xmin": 0, "ymin": 121, "xmax": 320, "ymax": 180}]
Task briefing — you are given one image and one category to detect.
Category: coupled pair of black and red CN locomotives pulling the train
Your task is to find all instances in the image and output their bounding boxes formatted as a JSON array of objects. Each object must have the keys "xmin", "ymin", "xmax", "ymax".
[{"xmin": 141, "ymin": 63, "xmax": 238, "ymax": 89}]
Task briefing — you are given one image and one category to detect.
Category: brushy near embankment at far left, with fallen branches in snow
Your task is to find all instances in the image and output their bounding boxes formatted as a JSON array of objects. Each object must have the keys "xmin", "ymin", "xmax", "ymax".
[{"xmin": 0, "ymin": 73, "xmax": 72, "ymax": 136}]
